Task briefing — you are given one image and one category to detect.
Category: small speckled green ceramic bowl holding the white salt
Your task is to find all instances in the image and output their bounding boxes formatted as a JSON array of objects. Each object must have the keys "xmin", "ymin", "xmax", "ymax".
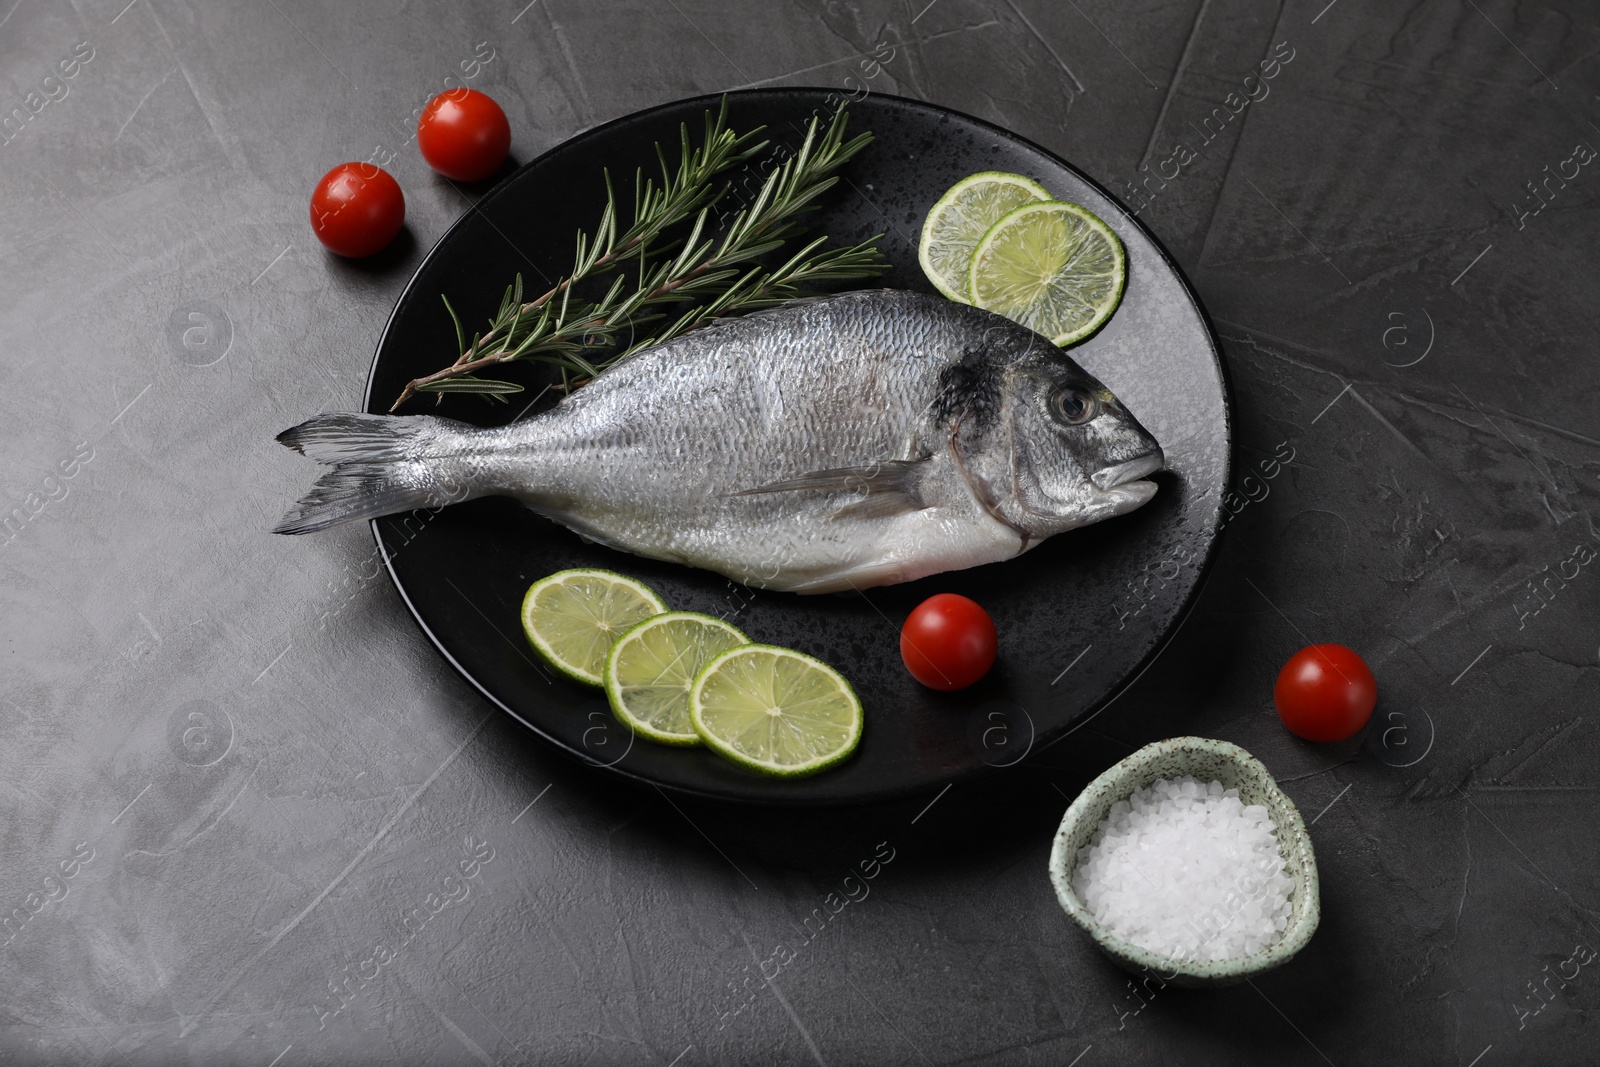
[{"xmin": 1050, "ymin": 737, "xmax": 1320, "ymax": 987}]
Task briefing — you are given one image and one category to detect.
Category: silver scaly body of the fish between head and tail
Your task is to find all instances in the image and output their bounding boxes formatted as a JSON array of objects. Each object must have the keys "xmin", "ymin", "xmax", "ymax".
[{"xmin": 474, "ymin": 291, "xmax": 1016, "ymax": 589}]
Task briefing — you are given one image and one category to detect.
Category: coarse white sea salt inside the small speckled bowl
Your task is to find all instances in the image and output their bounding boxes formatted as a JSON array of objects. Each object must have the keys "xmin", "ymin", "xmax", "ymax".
[{"xmin": 1072, "ymin": 776, "xmax": 1294, "ymax": 961}]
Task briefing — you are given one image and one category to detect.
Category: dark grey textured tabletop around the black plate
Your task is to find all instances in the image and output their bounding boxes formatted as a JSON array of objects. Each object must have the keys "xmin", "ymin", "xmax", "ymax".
[{"xmin": 0, "ymin": 0, "xmax": 1600, "ymax": 1067}]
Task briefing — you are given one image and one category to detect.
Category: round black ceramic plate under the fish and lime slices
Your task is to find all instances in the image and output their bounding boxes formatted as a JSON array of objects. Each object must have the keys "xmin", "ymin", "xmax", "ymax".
[{"xmin": 366, "ymin": 90, "xmax": 1229, "ymax": 803}]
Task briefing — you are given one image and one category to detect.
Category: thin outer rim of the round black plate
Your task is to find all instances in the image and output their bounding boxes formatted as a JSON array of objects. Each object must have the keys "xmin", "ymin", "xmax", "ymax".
[{"xmin": 362, "ymin": 86, "xmax": 1234, "ymax": 808}]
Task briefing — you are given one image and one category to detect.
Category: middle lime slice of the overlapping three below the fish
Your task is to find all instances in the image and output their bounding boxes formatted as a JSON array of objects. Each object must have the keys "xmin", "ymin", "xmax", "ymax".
[{"xmin": 602, "ymin": 611, "xmax": 750, "ymax": 745}]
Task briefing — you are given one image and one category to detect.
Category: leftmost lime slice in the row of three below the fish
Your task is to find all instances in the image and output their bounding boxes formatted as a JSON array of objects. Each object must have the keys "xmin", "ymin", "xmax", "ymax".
[{"xmin": 522, "ymin": 569, "xmax": 667, "ymax": 685}]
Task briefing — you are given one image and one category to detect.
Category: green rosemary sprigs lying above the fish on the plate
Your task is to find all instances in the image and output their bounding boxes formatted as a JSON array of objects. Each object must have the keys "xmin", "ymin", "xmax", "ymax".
[{"xmin": 390, "ymin": 101, "xmax": 888, "ymax": 411}]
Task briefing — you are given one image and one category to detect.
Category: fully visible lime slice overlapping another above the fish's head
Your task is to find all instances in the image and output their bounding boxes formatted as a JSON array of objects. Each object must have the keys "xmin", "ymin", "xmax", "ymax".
[{"xmin": 966, "ymin": 200, "xmax": 1128, "ymax": 344}]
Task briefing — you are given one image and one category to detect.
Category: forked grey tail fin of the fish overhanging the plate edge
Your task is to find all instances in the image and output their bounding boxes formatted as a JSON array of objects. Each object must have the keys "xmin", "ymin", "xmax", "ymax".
[{"xmin": 272, "ymin": 411, "xmax": 470, "ymax": 534}]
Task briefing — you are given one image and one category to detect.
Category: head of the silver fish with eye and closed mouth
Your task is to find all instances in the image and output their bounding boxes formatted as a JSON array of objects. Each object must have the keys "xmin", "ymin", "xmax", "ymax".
[{"xmin": 955, "ymin": 328, "xmax": 1166, "ymax": 541}]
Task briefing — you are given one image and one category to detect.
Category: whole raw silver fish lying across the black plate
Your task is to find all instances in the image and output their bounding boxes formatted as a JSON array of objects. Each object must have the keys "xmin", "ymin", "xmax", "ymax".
[{"xmin": 275, "ymin": 290, "xmax": 1163, "ymax": 593}]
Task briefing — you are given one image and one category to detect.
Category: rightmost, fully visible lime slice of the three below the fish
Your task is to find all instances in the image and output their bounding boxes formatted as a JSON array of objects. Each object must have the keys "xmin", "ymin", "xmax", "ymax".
[{"xmin": 690, "ymin": 645, "xmax": 861, "ymax": 777}]
